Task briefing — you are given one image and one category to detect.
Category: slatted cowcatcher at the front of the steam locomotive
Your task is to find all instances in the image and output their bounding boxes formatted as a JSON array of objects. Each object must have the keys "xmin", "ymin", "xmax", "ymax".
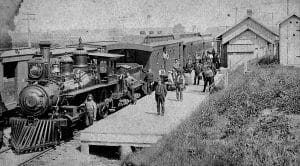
[{"xmin": 10, "ymin": 118, "xmax": 59, "ymax": 153}]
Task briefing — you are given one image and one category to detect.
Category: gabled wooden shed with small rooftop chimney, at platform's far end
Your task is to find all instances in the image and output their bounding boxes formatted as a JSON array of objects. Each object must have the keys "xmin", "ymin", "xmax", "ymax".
[{"xmin": 217, "ymin": 16, "xmax": 278, "ymax": 69}]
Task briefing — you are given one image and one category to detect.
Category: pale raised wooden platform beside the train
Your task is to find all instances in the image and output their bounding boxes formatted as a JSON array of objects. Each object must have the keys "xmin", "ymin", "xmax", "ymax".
[{"xmin": 80, "ymin": 74, "xmax": 225, "ymax": 153}]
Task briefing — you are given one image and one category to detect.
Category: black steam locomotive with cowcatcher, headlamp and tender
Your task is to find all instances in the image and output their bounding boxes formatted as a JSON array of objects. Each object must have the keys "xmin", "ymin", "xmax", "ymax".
[{"xmin": 10, "ymin": 42, "xmax": 146, "ymax": 153}]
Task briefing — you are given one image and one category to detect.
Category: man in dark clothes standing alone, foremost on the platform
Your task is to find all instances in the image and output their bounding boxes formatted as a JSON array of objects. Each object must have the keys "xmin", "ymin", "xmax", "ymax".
[{"xmin": 155, "ymin": 79, "xmax": 167, "ymax": 116}]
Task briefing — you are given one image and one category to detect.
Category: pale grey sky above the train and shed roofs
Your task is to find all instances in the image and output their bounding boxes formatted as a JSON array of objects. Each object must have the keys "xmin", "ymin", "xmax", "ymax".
[{"xmin": 15, "ymin": 0, "xmax": 300, "ymax": 32}]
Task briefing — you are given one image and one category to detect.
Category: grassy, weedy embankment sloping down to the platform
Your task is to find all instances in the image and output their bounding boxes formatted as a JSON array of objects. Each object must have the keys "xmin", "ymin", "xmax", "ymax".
[{"xmin": 127, "ymin": 58, "xmax": 300, "ymax": 166}]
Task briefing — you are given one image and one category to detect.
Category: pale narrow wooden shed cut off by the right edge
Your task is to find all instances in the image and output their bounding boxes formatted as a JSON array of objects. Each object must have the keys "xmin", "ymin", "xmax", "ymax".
[{"xmin": 279, "ymin": 14, "xmax": 300, "ymax": 67}]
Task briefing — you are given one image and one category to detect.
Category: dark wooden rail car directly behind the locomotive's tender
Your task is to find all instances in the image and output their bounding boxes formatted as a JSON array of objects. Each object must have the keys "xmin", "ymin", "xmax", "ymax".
[{"xmin": 68, "ymin": 36, "xmax": 183, "ymax": 84}]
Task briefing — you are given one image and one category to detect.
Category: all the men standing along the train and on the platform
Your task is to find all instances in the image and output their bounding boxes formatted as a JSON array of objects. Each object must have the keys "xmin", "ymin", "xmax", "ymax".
[{"xmin": 86, "ymin": 49, "xmax": 219, "ymax": 119}]
